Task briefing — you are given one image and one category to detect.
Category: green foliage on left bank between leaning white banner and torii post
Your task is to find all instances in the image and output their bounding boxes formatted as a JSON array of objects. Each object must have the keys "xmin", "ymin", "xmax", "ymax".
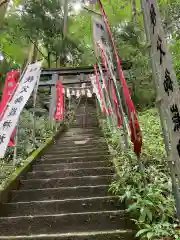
[{"xmin": 0, "ymin": 109, "xmax": 53, "ymax": 186}]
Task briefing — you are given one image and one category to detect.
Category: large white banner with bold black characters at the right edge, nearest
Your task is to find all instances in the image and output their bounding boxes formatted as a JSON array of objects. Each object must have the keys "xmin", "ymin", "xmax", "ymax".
[{"xmin": 143, "ymin": 0, "xmax": 180, "ymax": 176}]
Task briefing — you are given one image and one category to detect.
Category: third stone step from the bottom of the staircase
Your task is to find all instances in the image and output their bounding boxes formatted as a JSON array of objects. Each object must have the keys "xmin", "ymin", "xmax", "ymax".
[{"xmin": 1, "ymin": 196, "xmax": 124, "ymax": 217}]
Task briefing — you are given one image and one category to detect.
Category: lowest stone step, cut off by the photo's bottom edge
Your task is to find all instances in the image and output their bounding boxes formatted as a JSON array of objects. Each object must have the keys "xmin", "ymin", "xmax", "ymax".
[{"xmin": 1, "ymin": 230, "xmax": 135, "ymax": 240}]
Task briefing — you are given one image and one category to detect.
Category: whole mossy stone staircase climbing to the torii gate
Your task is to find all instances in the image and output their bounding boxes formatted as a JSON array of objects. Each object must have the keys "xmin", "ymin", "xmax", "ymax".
[{"xmin": 0, "ymin": 102, "xmax": 134, "ymax": 240}]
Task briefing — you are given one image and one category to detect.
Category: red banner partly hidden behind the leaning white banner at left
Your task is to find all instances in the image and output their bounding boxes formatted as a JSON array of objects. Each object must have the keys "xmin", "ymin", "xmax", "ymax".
[{"xmin": 0, "ymin": 69, "xmax": 19, "ymax": 146}]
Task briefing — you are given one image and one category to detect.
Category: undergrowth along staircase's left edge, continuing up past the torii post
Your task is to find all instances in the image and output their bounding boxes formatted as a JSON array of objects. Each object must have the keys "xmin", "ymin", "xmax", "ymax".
[{"xmin": 0, "ymin": 102, "xmax": 75, "ymax": 189}]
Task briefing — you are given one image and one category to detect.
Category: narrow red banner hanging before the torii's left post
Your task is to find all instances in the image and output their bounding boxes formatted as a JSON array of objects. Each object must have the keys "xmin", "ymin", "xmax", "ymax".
[{"xmin": 54, "ymin": 80, "xmax": 64, "ymax": 120}]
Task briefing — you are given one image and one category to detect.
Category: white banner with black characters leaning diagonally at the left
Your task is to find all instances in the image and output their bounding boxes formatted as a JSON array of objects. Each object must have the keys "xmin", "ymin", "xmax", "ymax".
[{"xmin": 0, "ymin": 61, "xmax": 42, "ymax": 158}]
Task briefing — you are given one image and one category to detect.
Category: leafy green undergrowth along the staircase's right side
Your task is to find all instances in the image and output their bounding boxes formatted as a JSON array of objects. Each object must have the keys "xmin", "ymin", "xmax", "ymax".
[{"xmin": 100, "ymin": 109, "xmax": 180, "ymax": 240}]
